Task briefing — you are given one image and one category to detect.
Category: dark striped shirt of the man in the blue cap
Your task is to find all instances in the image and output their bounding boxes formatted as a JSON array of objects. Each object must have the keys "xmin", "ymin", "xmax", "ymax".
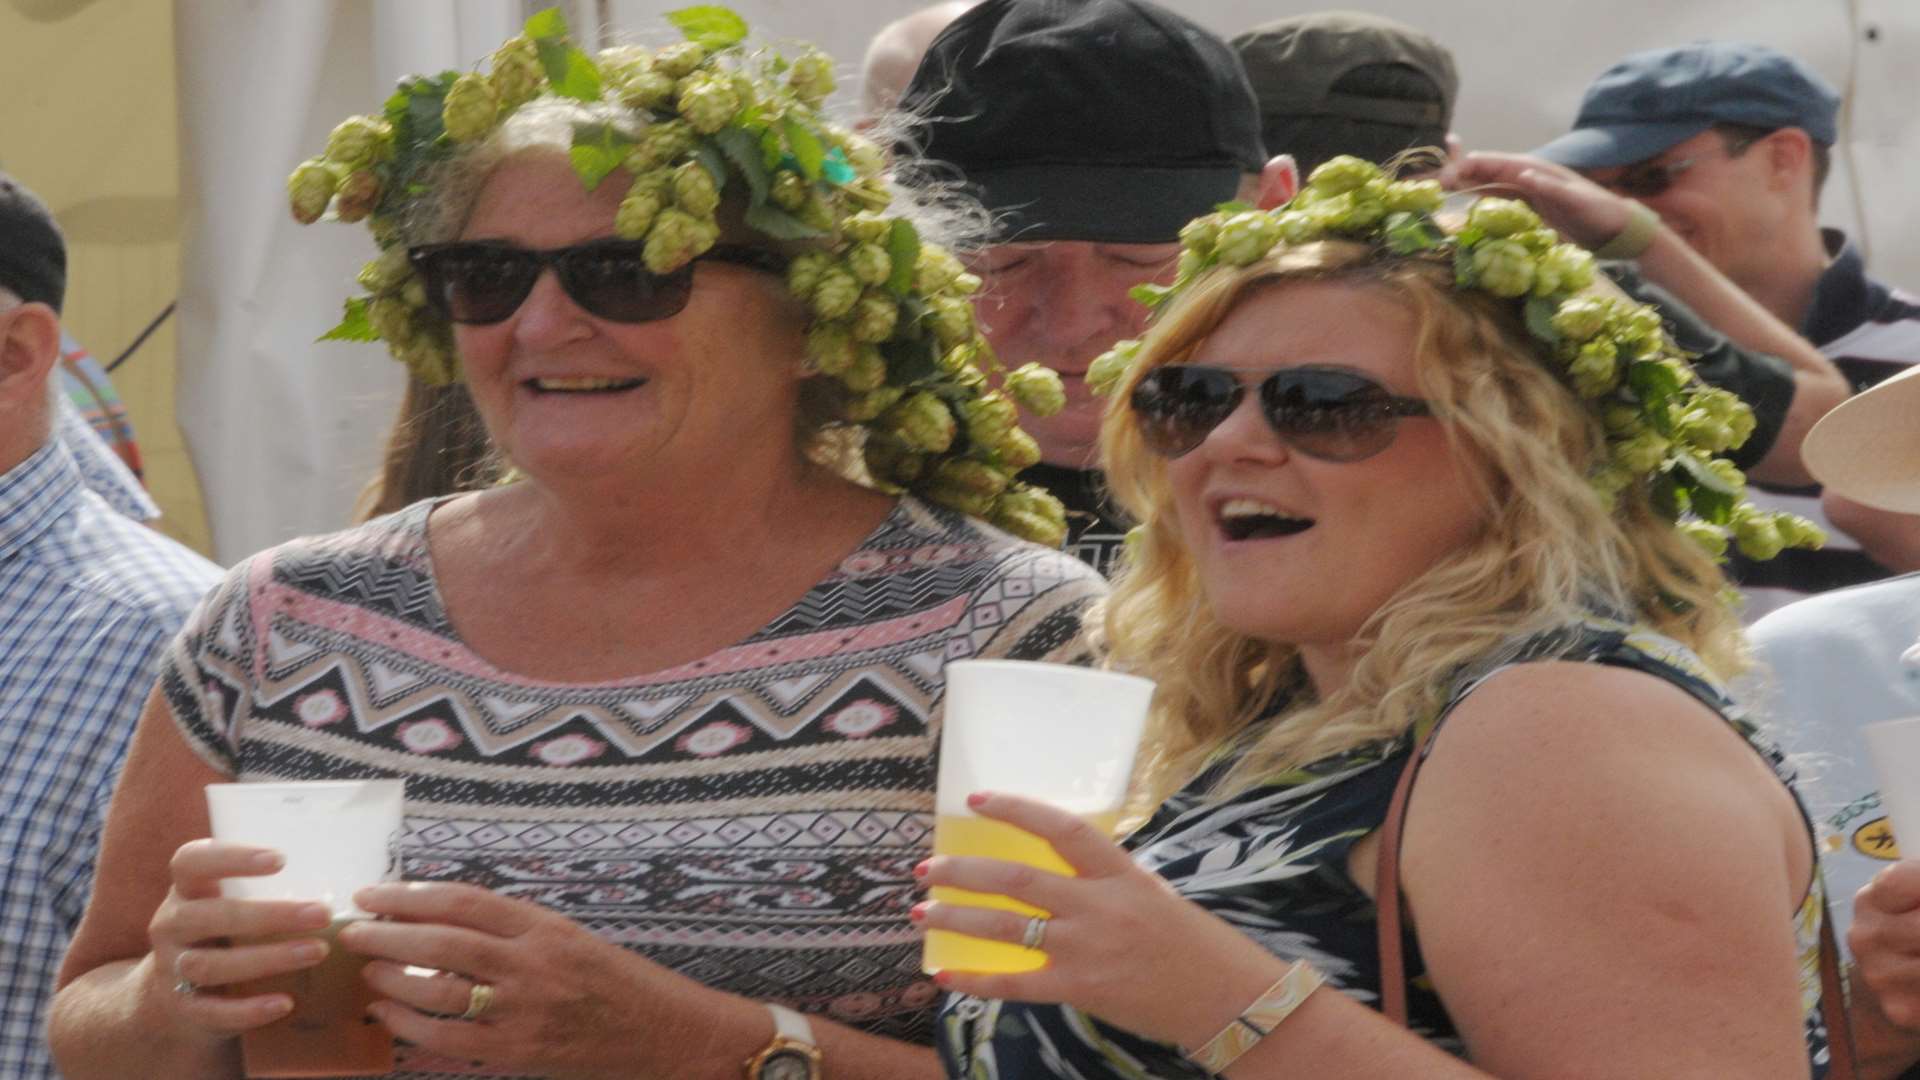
[{"xmin": 1726, "ymin": 229, "xmax": 1920, "ymax": 623}]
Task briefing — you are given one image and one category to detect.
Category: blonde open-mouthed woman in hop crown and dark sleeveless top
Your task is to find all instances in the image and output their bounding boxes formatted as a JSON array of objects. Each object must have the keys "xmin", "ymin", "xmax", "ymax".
[{"xmin": 916, "ymin": 158, "xmax": 1843, "ymax": 1080}]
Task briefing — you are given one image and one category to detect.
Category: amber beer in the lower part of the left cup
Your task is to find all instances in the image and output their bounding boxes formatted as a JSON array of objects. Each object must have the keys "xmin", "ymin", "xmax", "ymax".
[{"xmin": 234, "ymin": 919, "xmax": 394, "ymax": 1076}]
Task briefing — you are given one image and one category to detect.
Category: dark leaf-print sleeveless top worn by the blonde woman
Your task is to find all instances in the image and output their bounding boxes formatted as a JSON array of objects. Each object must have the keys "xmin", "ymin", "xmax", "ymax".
[{"xmin": 939, "ymin": 617, "xmax": 1828, "ymax": 1080}]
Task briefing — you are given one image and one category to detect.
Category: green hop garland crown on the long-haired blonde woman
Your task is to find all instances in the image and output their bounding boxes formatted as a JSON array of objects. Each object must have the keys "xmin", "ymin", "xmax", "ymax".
[{"xmin": 1087, "ymin": 156, "xmax": 1826, "ymax": 559}]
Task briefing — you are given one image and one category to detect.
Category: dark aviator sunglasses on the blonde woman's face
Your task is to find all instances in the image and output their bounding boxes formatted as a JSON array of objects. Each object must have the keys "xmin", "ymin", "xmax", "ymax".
[{"xmin": 1131, "ymin": 363, "xmax": 1432, "ymax": 461}]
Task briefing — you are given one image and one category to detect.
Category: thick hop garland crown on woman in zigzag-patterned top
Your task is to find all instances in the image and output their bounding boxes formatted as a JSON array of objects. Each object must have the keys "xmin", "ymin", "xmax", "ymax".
[{"xmin": 286, "ymin": 6, "xmax": 1066, "ymax": 546}]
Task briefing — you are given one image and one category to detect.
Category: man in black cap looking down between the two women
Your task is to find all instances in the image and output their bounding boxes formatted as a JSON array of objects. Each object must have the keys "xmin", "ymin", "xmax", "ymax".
[{"xmin": 902, "ymin": 0, "xmax": 1294, "ymax": 571}]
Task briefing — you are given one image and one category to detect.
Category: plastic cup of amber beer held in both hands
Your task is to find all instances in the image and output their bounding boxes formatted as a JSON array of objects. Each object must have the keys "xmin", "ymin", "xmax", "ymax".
[{"xmin": 207, "ymin": 780, "xmax": 405, "ymax": 1076}]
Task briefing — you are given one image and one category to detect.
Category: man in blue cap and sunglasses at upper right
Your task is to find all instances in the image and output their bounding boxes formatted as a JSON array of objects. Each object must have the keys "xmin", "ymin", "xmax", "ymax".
[{"xmin": 1538, "ymin": 42, "xmax": 1920, "ymax": 617}]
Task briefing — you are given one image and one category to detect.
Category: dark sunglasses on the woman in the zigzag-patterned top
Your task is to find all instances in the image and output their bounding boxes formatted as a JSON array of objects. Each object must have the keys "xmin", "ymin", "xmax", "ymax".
[{"xmin": 407, "ymin": 240, "xmax": 787, "ymax": 325}]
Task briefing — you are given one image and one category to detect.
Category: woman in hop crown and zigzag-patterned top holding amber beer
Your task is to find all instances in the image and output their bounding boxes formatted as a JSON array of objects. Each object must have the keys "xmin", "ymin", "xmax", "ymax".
[{"xmin": 52, "ymin": 10, "xmax": 1104, "ymax": 1080}]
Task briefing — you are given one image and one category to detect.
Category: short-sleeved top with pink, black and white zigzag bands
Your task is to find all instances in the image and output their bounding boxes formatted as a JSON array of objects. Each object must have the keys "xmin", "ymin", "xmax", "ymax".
[{"xmin": 163, "ymin": 498, "xmax": 1106, "ymax": 1078}]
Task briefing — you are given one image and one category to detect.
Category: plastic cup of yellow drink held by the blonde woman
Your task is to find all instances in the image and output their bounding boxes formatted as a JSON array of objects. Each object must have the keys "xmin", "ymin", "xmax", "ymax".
[{"xmin": 920, "ymin": 659, "xmax": 1154, "ymax": 974}]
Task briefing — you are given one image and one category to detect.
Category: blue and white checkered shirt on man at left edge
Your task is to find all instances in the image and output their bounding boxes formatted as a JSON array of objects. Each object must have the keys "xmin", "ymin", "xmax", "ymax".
[{"xmin": 0, "ymin": 440, "xmax": 221, "ymax": 1080}]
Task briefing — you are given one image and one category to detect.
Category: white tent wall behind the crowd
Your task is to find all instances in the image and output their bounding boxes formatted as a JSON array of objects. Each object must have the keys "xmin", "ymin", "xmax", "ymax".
[{"xmin": 175, "ymin": 0, "xmax": 1920, "ymax": 563}]
